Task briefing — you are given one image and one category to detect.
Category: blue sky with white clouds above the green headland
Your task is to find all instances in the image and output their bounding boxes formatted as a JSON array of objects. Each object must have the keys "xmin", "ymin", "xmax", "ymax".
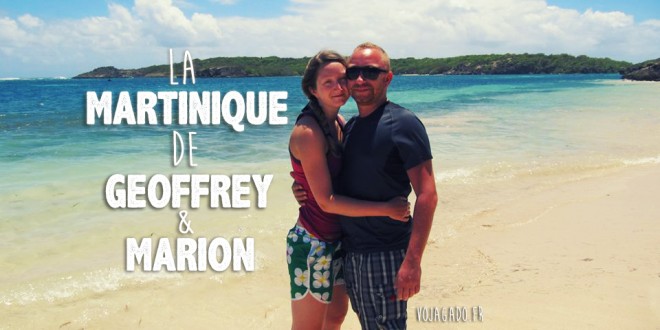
[{"xmin": 0, "ymin": 0, "xmax": 660, "ymax": 78}]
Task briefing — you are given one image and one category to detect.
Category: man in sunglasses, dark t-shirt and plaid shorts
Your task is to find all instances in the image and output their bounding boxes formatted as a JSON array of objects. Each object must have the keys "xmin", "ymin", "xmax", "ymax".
[{"xmin": 296, "ymin": 43, "xmax": 437, "ymax": 329}]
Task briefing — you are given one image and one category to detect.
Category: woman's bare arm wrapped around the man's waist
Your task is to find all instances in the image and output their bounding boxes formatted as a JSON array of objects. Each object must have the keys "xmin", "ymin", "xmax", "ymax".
[{"xmin": 289, "ymin": 117, "xmax": 410, "ymax": 221}]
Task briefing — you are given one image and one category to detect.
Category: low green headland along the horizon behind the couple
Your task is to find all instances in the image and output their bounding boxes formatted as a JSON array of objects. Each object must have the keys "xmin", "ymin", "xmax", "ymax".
[{"xmin": 74, "ymin": 54, "xmax": 660, "ymax": 81}]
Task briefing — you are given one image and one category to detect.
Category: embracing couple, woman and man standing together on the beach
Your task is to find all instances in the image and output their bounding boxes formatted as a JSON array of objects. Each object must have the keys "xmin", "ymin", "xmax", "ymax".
[{"xmin": 287, "ymin": 43, "xmax": 437, "ymax": 329}]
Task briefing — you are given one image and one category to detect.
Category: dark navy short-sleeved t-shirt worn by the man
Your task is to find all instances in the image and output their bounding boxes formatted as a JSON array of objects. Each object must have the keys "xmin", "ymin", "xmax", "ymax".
[{"xmin": 339, "ymin": 102, "xmax": 432, "ymax": 252}]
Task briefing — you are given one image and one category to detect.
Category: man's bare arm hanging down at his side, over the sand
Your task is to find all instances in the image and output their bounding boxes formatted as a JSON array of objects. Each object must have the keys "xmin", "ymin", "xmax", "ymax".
[{"xmin": 396, "ymin": 159, "xmax": 438, "ymax": 300}]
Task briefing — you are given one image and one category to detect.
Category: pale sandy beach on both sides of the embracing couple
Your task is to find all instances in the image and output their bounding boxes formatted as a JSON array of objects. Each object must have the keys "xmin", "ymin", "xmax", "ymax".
[{"xmin": 0, "ymin": 162, "xmax": 660, "ymax": 329}]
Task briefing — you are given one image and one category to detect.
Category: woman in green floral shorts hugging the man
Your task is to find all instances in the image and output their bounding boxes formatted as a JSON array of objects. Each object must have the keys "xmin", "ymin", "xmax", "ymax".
[{"xmin": 287, "ymin": 51, "xmax": 410, "ymax": 329}]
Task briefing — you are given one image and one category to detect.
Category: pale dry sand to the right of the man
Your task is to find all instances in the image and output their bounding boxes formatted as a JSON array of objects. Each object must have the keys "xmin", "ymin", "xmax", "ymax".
[{"xmin": 409, "ymin": 164, "xmax": 660, "ymax": 329}]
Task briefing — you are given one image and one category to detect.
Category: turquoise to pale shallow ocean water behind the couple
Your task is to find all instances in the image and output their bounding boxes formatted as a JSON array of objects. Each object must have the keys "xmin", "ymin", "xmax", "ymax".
[{"xmin": 0, "ymin": 75, "xmax": 660, "ymax": 327}]
